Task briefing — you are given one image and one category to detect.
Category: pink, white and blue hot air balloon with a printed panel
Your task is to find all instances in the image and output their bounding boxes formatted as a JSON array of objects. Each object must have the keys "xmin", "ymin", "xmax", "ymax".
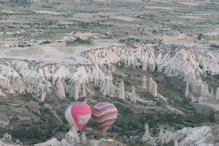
[{"xmin": 65, "ymin": 102, "xmax": 91, "ymax": 131}]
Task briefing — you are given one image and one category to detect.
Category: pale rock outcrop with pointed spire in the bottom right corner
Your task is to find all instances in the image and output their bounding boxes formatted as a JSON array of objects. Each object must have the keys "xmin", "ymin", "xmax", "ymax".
[{"xmin": 141, "ymin": 124, "xmax": 219, "ymax": 146}]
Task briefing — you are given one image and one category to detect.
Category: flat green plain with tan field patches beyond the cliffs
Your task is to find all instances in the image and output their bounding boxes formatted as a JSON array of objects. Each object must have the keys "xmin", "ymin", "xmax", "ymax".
[{"xmin": 0, "ymin": 0, "xmax": 219, "ymax": 46}]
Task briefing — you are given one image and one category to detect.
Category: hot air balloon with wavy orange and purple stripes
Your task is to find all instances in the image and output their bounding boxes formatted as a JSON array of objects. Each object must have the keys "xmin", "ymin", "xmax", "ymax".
[{"xmin": 92, "ymin": 102, "xmax": 118, "ymax": 133}]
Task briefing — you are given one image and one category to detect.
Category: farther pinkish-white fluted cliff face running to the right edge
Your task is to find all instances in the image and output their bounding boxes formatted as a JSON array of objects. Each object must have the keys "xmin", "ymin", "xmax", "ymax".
[{"xmin": 85, "ymin": 45, "xmax": 219, "ymax": 81}]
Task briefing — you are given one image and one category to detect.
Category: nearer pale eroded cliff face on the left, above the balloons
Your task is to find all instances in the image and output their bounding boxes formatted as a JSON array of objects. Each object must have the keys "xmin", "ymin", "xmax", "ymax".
[{"xmin": 0, "ymin": 60, "xmax": 110, "ymax": 101}]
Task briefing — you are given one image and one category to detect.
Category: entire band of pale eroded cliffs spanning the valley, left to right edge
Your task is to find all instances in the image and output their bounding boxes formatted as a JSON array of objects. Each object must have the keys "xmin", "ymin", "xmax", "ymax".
[{"xmin": 0, "ymin": 45, "xmax": 219, "ymax": 101}]
